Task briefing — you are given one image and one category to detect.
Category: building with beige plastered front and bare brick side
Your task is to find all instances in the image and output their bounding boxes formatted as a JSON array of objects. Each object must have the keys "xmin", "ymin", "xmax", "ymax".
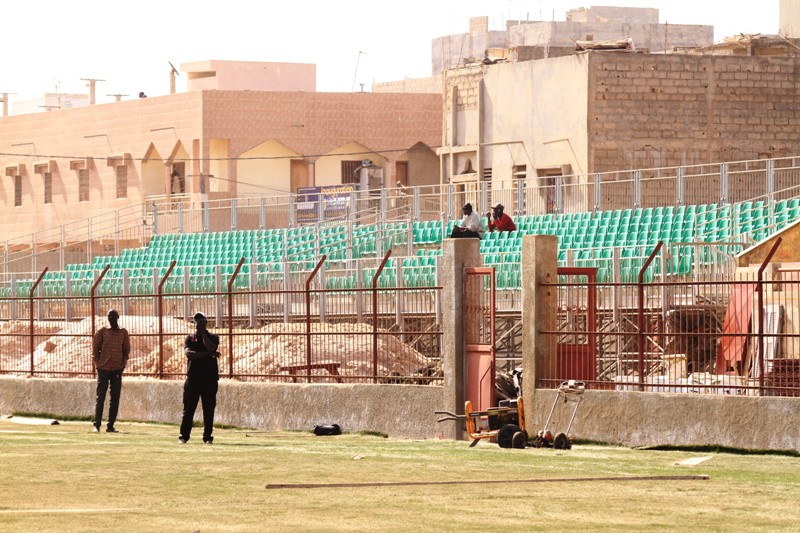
[{"xmin": 439, "ymin": 47, "xmax": 800, "ymax": 210}]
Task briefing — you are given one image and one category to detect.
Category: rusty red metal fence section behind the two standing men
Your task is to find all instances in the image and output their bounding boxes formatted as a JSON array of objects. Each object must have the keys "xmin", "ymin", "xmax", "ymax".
[{"xmin": 0, "ymin": 254, "xmax": 442, "ymax": 384}]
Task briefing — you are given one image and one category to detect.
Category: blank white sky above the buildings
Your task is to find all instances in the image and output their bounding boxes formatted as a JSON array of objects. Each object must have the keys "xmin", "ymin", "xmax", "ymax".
[{"xmin": 0, "ymin": 0, "xmax": 779, "ymax": 106}]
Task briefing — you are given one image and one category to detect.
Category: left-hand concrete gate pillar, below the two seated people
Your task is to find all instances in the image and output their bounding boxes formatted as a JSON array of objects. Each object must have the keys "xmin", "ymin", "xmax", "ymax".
[{"xmin": 441, "ymin": 239, "xmax": 482, "ymax": 439}]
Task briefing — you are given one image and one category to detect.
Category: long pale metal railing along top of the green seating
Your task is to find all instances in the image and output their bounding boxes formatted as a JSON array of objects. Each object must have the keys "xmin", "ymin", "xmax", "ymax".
[{"xmin": 3, "ymin": 158, "xmax": 800, "ymax": 272}]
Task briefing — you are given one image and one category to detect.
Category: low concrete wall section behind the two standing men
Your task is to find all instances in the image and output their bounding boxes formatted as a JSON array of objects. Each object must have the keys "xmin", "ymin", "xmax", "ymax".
[{"xmin": 0, "ymin": 377, "xmax": 444, "ymax": 438}]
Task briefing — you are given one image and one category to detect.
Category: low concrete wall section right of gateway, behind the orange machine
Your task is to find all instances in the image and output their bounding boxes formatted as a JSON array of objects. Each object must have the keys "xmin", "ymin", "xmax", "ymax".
[{"xmin": 526, "ymin": 389, "xmax": 800, "ymax": 451}]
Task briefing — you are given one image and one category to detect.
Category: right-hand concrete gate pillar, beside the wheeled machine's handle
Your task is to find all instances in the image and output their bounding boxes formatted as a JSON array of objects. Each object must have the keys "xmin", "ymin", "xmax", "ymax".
[{"xmin": 522, "ymin": 235, "xmax": 558, "ymax": 420}]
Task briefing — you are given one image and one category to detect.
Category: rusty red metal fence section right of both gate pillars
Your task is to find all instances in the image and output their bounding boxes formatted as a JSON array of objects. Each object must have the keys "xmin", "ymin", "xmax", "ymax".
[{"xmin": 540, "ymin": 238, "xmax": 800, "ymax": 396}]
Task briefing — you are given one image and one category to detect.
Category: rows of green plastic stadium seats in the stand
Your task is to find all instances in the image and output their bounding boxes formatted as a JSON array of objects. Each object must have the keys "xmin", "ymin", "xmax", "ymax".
[{"xmin": 15, "ymin": 198, "xmax": 800, "ymax": 298}]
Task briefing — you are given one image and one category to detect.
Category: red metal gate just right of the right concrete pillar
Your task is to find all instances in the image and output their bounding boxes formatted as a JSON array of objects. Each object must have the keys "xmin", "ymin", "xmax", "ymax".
[{"xmin": 556, "ymin": 267, "xmax": 597, "ymax": 381}]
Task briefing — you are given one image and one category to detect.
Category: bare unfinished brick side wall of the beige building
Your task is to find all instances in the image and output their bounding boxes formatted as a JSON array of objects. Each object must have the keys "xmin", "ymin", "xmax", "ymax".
[{"xmin": 588, "ymin": 53, "xmax": 800, "ymax": 206}]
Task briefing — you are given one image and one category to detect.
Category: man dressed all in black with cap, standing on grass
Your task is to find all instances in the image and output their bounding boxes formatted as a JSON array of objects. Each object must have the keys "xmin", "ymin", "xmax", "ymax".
[{"xmin": 178, "ymin": 313, "xmax": 220, "ymax": 444}]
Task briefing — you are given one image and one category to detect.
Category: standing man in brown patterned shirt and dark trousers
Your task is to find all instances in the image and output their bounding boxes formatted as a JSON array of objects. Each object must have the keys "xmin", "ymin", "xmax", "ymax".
[{"xmin": 92, "ymin": 309, "xmax": 131, "ymax": 433}]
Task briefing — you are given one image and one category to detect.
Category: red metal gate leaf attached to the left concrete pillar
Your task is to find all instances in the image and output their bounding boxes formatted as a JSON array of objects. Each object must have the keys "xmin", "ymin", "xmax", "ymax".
[{"xmin": 464, "ymin": 267, "xmax": 496, "ymax": 411}]
